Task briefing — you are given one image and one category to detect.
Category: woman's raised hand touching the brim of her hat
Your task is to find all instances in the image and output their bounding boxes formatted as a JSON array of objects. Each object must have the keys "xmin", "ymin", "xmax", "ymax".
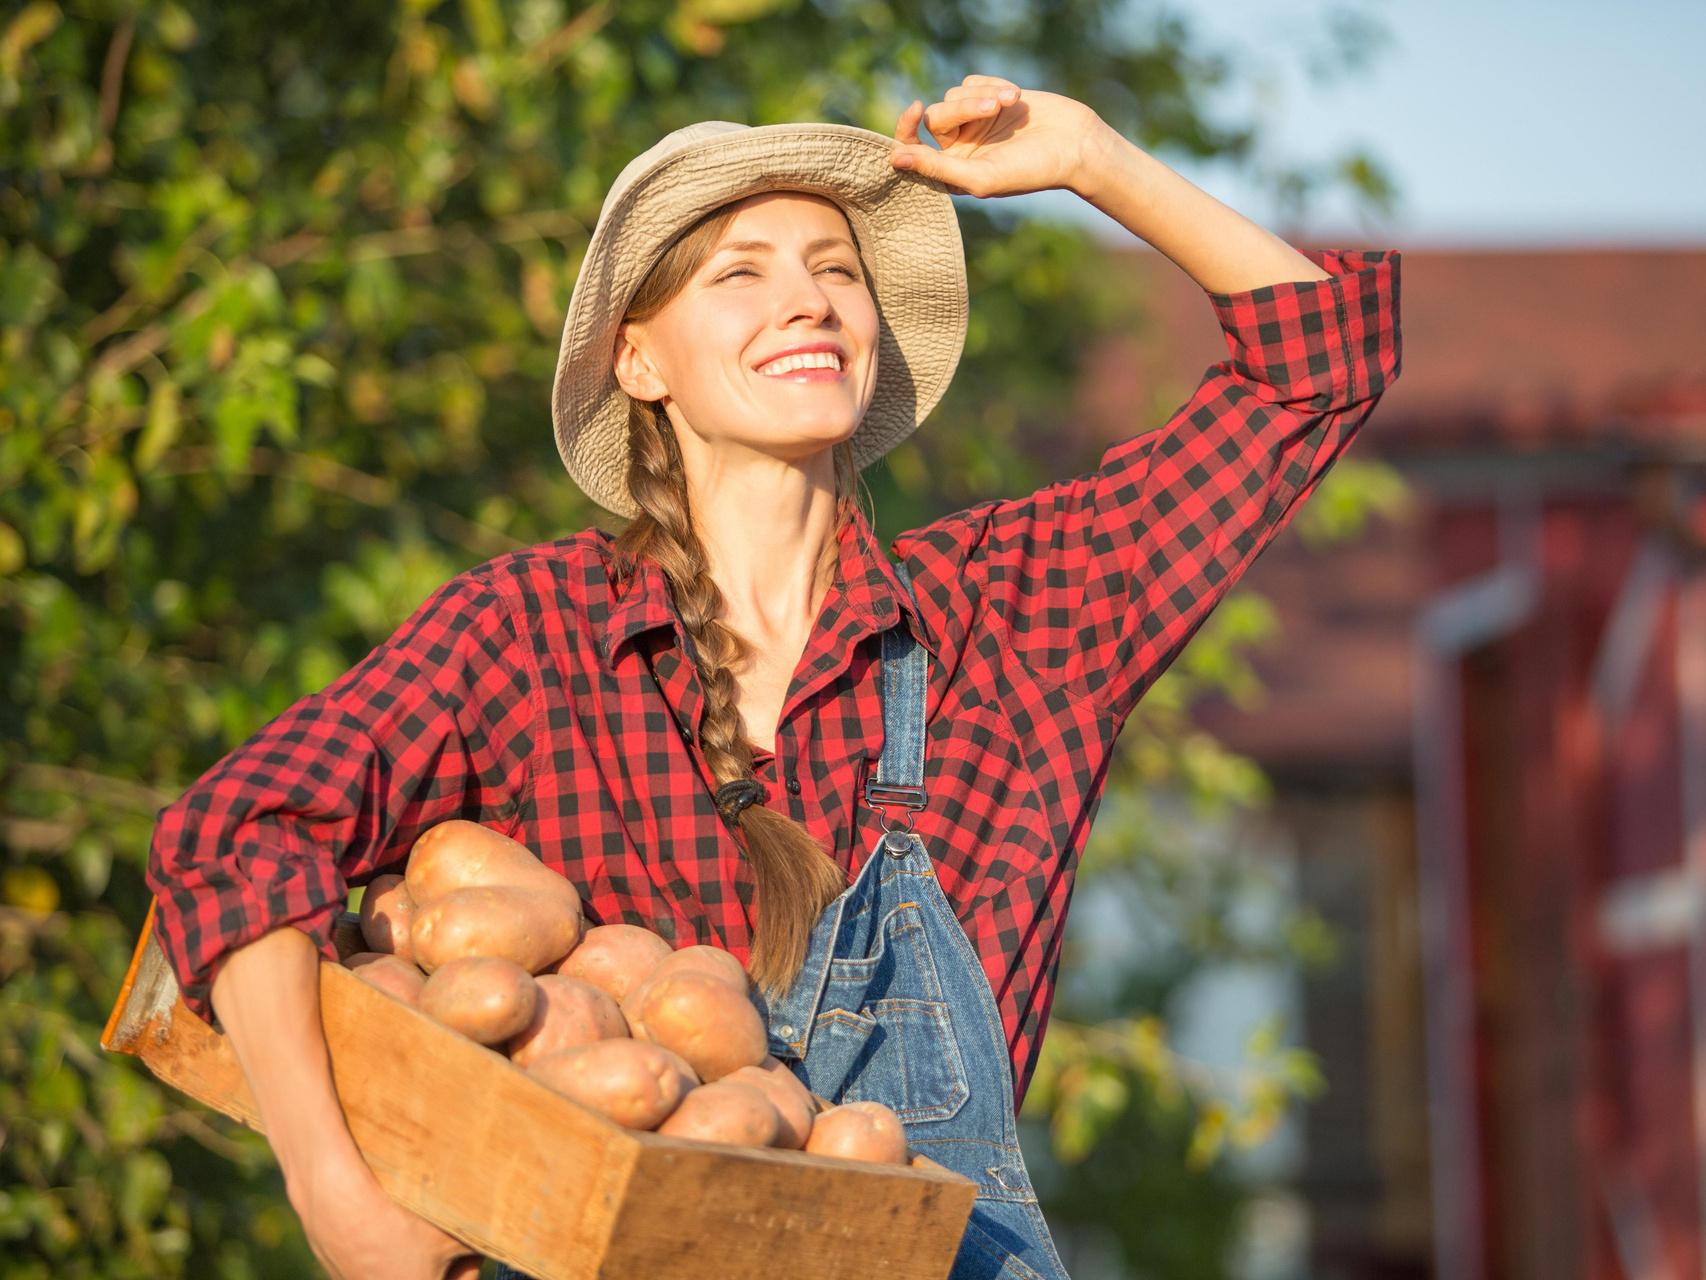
[{"xmin": 889, "ymin": 75, "xmax": 1107, "ymax": 196}]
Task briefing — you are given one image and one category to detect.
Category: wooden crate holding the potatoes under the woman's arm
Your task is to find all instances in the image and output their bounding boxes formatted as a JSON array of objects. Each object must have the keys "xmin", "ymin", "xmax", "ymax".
[{"xmin": 101, "ymin": 905, "xmax": 976, "ymax": 1280}]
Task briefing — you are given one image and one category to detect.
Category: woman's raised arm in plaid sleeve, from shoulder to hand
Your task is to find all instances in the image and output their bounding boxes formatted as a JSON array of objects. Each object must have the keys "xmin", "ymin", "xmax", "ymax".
[{"xmin": 892, "ymin": 89, "xmax": 1401, "ymax": 722}]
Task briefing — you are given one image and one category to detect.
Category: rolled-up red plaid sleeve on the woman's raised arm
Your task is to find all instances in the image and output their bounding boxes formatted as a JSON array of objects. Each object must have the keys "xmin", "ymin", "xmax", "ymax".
[{"xmin": 894, "ymin": 249, "xmax": 1401, "ymax": 722}]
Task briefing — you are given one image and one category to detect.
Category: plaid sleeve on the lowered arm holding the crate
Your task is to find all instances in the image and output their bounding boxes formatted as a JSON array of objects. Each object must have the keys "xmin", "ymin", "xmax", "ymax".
[{"xmin": 147, "ymin": 573, "xmax": 537, "ymax": 1022}]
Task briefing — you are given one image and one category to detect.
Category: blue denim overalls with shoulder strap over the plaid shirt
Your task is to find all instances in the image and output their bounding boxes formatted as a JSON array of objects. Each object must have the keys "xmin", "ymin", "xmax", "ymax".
[{"xmin": 498, "ymin": 565, "xmax": 1068, "ymax": 1280}]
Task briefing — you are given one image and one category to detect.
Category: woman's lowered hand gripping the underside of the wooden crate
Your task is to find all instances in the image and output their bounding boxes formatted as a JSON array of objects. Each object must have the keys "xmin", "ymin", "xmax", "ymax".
[{"xmin": 290, "ymin": 1166, "xmax": 481, "ymax": 1280}]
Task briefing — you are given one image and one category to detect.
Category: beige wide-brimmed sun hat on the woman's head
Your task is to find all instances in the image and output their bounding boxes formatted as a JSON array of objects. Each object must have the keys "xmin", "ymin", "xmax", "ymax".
[{"xmin": 551, "ymin": 119, "xmax": 966, "ymax": 517}]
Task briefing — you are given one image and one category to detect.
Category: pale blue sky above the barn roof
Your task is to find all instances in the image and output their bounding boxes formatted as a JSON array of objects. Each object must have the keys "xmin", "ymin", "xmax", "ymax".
[{"xmin": 996, "ymin": 0, "xmax": 1706, "ymax": 247}]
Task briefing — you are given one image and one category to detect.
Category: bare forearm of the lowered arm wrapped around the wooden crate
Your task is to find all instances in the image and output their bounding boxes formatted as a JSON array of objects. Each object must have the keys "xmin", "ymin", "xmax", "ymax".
[{"xmin": 212, "ymin": 925, "xmax": 367, "ymax": 1200}]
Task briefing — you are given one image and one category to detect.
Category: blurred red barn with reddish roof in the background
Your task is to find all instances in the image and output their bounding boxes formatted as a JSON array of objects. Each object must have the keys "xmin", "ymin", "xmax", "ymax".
[{"xmin": 1080, "ymin": 241, "xmax": 1706, "ymax": 1280}]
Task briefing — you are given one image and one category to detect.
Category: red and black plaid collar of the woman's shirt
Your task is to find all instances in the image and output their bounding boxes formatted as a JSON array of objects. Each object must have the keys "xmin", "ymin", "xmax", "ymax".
[{"xmin": 599, "ymin": 507, "xmax": 942, "ymax": 667}]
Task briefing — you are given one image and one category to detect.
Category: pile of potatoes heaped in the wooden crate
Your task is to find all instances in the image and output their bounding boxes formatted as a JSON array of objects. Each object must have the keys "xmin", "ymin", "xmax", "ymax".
[{"xmin": 345, "ymin": 821, "xmax": 906, "ymax": 1164}]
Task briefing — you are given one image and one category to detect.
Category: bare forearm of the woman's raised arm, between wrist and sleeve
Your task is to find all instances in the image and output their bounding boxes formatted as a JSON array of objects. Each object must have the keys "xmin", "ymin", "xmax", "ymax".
[{"xmin": 1071, "ymin": 125, "xmax": 1329, "ymax": 294}]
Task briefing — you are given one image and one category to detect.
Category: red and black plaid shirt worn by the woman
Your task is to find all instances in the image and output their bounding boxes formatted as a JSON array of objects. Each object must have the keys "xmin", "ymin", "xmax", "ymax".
[{"xmin": 148, "ymin": 251, "xmax": 1399, "ymax": 1108}]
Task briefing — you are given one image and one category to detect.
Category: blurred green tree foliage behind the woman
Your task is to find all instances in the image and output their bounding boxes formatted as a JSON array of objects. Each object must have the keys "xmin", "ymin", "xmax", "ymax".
[{"xmin": 0, "ymin": 0, "xmax": 1382, "ymax": 1280}]
